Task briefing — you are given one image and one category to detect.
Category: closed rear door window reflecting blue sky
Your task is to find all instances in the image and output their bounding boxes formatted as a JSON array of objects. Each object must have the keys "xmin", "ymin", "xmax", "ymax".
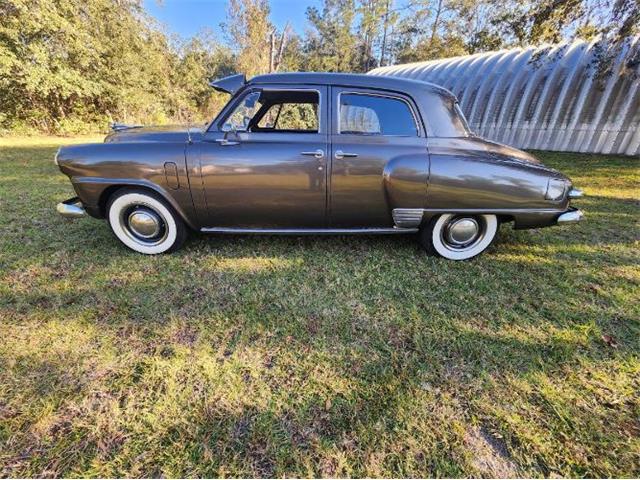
[{"xmin": 339, "ymin": 93, "xmax": 418, "ymax": 137}]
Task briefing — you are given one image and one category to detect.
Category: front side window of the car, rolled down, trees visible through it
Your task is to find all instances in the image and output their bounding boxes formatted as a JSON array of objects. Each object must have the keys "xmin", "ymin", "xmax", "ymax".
[{"xmin": 223, "ymin": 90, "xmax": 320, "ymax": 133}]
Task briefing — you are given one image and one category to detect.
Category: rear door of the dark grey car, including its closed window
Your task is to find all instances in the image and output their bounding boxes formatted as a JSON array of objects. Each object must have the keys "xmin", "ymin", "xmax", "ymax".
[{"xmin": 329, "ymin": 87, "xmax": 429, "ymax": 228}]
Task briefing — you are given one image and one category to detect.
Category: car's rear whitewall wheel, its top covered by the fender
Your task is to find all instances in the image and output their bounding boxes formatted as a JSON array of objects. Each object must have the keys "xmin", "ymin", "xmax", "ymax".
[{"xmin": 420, "ymin": 213, "xmax": 498, "ymax": 260}]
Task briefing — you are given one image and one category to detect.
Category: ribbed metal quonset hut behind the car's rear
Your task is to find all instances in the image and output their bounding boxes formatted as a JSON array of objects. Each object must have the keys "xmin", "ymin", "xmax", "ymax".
[{"xmin": 369, "ymin": 37, "xmax": 640, "ymax": 155}]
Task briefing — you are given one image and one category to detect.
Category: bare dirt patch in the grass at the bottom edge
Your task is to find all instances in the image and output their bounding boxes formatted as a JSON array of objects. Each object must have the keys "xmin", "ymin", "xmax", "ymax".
[{"xmin": 464, "ymin": 427, "xmax": 518, "ymax": 478}]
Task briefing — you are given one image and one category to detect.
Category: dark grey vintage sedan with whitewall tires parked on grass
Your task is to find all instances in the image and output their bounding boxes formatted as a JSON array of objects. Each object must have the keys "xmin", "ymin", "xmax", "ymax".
[{"xmin": 55, "ymin": 73, "xmax": 583, "ymax": 260}]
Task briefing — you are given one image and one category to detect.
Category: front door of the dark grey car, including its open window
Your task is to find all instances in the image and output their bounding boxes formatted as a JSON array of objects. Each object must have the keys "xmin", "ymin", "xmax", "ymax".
[{"xmin": 196, "ymin": 85, "xmax": 329, "ymax": 229}]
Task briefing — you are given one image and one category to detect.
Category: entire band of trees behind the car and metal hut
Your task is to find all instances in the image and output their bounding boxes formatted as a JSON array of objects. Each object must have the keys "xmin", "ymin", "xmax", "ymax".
[{"xmin": 0, "ymin": 0, "xmax": 640, "ymax": 134}]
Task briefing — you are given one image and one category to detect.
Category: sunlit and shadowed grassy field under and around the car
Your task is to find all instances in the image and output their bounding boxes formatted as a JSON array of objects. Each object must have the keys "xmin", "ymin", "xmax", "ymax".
[{"xmin": 0, "ymin": 139, "xmax": 640, "ymax": 477}]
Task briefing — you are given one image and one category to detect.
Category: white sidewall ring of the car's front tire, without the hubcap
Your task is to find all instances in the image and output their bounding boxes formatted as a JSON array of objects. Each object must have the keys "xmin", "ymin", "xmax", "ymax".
[{"xmin": 107, "ymin": 190, "xmax": 184, "ymax": 255}]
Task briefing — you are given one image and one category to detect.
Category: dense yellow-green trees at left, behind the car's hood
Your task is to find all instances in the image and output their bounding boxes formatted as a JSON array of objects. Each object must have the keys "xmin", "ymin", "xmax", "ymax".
[{"xmin": 0, "ymin": 0, "xmax": 233, "ymax": 133}]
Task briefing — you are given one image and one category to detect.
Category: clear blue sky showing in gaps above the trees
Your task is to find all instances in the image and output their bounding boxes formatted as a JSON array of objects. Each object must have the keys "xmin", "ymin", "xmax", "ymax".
[{"xmin": 144, "ymin": 0, "xmax": 320, "ymax": 39}]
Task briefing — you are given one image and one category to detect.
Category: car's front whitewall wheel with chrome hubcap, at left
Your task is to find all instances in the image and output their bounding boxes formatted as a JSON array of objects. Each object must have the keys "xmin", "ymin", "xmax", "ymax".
[{"xmin": 107, "ymin": 188, "xmax": 187, "ymax": 255}]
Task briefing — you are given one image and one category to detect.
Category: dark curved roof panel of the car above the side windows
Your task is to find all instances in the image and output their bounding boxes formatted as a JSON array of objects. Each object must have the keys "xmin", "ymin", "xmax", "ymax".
[{"xmin": 247, "ymin": 72, "xmax": 454, "ymax": 97}]
